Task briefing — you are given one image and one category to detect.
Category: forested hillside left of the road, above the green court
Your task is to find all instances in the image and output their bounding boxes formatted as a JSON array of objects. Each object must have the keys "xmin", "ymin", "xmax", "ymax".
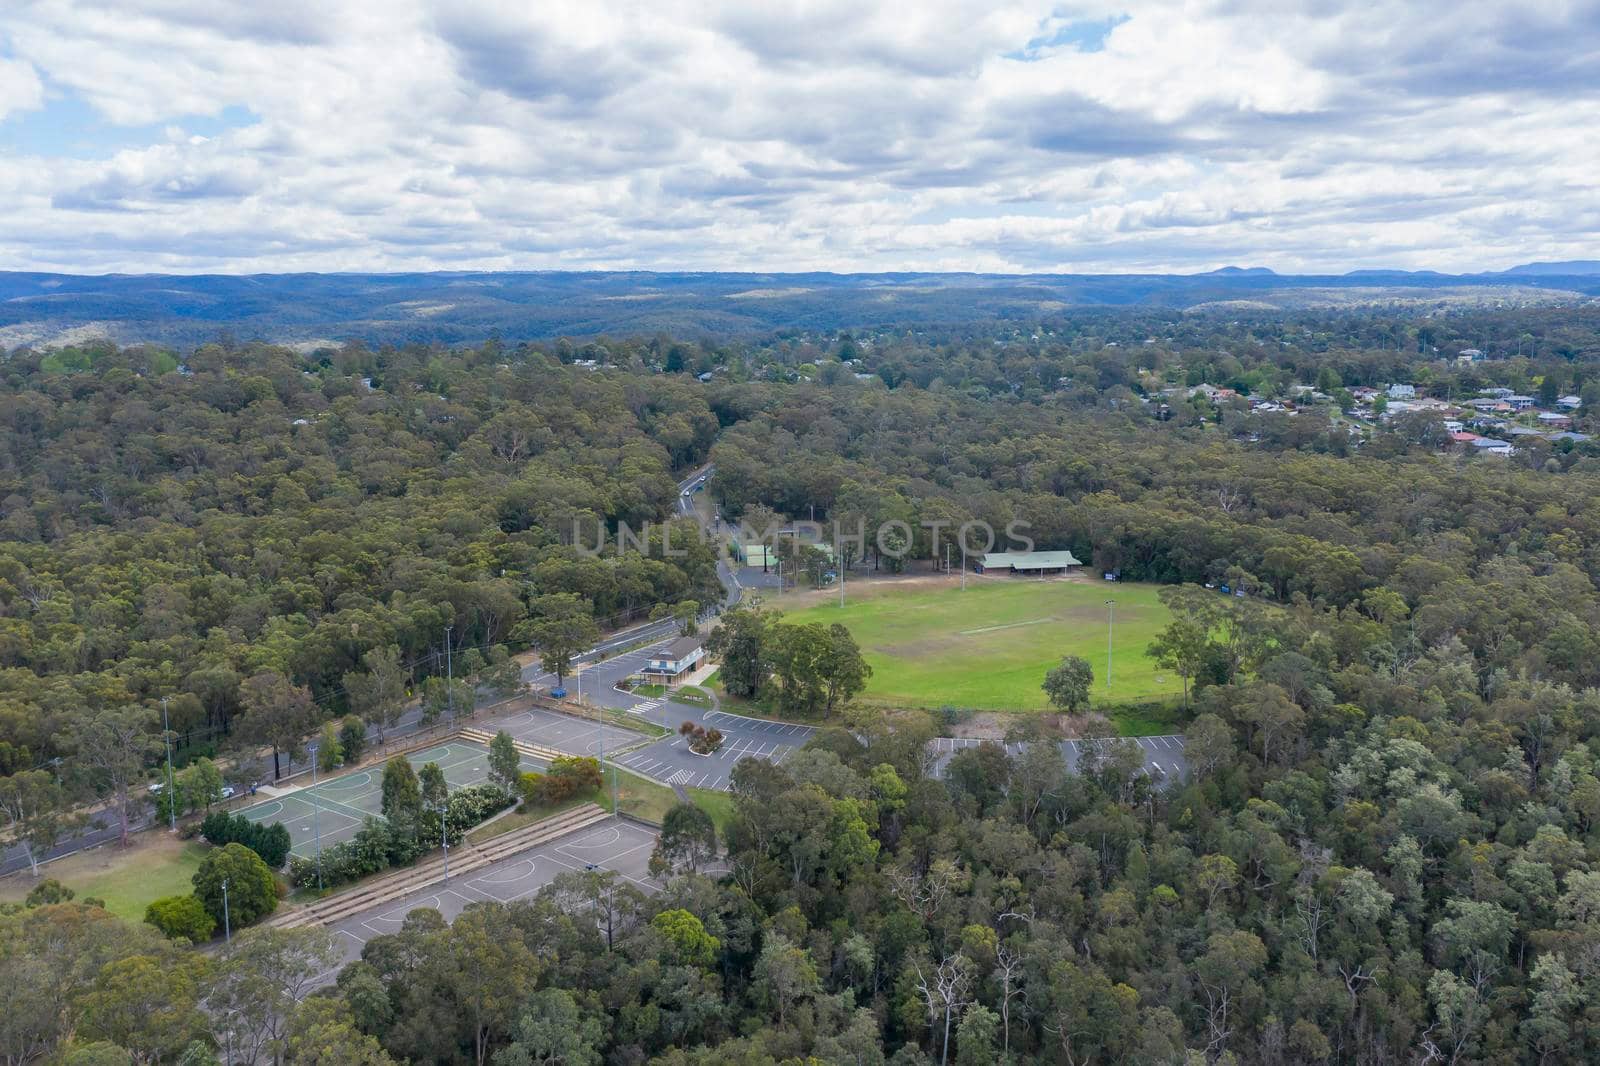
[{"xmin": 0, "ymin": 337, "xmax": 718, "ymax": 771}]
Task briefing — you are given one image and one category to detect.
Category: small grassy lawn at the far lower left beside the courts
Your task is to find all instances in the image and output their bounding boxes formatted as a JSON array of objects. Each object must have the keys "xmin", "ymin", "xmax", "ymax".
[{"xmin": 0, "ymin": 831, "xmax": 210, "ymax": 922}]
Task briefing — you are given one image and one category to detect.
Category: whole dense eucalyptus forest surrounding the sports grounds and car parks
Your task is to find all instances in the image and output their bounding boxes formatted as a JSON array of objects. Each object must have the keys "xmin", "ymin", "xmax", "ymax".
[{"xmin": 9, "ymin": 302, "xmax": 1600, "ymax": 1066}]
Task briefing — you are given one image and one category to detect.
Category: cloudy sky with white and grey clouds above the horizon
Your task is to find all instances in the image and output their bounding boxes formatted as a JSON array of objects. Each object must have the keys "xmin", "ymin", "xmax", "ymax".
[{"xmin": 0, "ymin": 0, "xmax": 1600, "ymax": 272}]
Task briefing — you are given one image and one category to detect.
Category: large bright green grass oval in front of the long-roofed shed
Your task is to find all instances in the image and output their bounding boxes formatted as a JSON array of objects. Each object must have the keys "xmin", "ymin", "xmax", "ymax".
[{"xmin": 766, "ymin": 576, "xmax": 1182, "ymax": 711}]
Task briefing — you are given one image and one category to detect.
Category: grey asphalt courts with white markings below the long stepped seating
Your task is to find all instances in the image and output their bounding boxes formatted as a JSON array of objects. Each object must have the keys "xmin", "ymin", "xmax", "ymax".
[{"xmin": 325, "ymin": 818, "xmax": 658, "ymax": 980}]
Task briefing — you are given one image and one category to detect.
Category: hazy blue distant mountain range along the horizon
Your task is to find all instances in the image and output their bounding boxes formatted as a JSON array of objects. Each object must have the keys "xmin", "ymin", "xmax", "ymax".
[{"xmin": 0, "ymin": 261, "xmax": 1600, "ymax": 349}]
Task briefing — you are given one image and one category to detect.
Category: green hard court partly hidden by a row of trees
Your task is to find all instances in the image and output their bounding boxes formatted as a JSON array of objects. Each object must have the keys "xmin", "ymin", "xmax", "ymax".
[{"xmin": 240, "ymin": 739, "xmax": 544, "ymax": 858}]
